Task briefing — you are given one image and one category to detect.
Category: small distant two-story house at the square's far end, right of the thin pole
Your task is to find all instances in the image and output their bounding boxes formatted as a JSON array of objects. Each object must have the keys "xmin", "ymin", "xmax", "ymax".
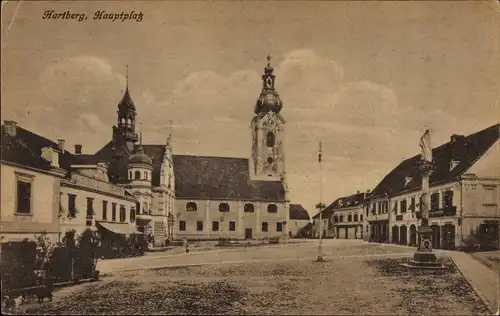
[{"xmin": 329, "ymin": 191, "xmax": 366, "ymax": 239}]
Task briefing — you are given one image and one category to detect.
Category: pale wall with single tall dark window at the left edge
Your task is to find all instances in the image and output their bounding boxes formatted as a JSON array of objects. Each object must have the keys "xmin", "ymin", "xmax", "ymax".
[{"xmin": 0, "ymin": 163, "xmax": 59, "ymax": 239}]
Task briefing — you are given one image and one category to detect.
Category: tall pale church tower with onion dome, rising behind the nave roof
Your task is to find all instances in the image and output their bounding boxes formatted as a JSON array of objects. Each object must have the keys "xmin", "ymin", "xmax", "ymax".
[{"xmin": 251, "ymin": 56, "xmax": 286, "ymax": 181}]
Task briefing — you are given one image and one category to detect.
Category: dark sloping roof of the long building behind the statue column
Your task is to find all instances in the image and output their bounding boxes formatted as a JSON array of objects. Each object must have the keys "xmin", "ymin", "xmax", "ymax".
[{"xmin": 370, "ymin": 124, "xmax": 500, "ymax": 197}]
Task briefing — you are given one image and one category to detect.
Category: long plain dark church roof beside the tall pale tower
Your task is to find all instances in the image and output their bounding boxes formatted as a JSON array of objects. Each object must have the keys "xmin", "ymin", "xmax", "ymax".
[{"xmin": 173, "ymin": 155, "xmax": 285, "ymax": 201}]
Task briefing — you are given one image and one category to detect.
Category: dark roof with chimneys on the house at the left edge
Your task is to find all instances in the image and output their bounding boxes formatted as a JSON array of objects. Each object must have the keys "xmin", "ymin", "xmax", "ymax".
[{"xmin": 1, "ymin": 125, "xmax": 73, "ymax": 171}]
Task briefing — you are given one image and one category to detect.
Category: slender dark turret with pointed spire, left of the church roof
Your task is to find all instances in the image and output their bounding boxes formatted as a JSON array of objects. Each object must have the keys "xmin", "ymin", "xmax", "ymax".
[{"xmin": 113, "ymin": 67, "xmax": 138, "ymax": 156}]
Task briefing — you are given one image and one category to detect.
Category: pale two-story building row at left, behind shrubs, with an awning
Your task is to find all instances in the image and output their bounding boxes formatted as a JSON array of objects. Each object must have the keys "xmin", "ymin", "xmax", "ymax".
[{"xmin": 0, "ymin": 121, "xmax": 141, "ymax": 241}]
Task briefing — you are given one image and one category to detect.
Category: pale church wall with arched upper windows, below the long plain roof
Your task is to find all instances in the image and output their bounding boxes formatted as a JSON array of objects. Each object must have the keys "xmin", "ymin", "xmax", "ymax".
[{"xmin": 174, "ymin": 199, "xmax": 289, "ymax": 239}]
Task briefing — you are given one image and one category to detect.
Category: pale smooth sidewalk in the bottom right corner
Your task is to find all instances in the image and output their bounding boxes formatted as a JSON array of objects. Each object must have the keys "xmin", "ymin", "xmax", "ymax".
[{"xmin": 448, "ymin": 251, "xmax": 500, "ymax": 312}]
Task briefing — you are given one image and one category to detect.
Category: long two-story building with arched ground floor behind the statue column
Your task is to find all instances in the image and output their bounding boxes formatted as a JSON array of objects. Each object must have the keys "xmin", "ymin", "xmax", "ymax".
[{"xmin": 365, "ymin": 124, "xmax": 500, "ymax": 249}]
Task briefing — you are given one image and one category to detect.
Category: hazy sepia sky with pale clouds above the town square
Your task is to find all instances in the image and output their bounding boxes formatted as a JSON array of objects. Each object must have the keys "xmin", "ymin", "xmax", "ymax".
[{"xmin": 1, "ymin": 1, "xmax": 500, "ymax": 214}]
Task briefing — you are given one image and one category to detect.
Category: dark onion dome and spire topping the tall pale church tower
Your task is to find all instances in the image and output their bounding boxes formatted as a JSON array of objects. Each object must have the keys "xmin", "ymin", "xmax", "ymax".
[{"xmin": 254, "ymin": 56, "xmax": 283, "ymax": 114}]
